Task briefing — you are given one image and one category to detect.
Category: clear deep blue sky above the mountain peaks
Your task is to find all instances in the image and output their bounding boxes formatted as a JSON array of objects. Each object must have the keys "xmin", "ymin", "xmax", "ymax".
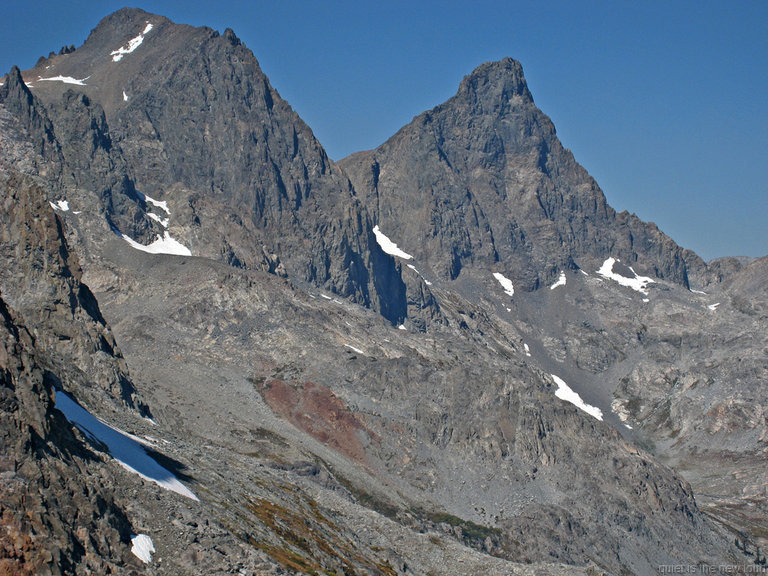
[{"xmin": 0, "ymin": 0, "xmax": 768, "ymax": 259}]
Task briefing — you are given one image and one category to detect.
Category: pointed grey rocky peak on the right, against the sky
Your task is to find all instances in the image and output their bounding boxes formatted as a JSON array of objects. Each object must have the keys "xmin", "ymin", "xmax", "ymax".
[{"xmin": 339, "ymin": 58, "xmax": 704, "ymax": 290}]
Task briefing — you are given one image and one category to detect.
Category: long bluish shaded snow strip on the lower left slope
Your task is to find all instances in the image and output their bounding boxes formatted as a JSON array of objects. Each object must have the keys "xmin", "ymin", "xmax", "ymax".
[{"xmin": 54, "ymin": 390, "xmax": 198, "ymax": 500}]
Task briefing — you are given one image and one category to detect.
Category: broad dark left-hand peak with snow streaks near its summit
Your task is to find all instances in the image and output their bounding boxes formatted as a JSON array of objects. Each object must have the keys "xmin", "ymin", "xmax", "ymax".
[{"xmin": 13, "ymin": 9, "xmax": 405, "ymax": 323}]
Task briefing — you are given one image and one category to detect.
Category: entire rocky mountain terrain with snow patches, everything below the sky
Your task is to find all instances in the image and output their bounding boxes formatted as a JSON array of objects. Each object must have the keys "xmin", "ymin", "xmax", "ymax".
[{"xmin": 0, "ymin": 9, "xmax": 768, "ymax": 575}]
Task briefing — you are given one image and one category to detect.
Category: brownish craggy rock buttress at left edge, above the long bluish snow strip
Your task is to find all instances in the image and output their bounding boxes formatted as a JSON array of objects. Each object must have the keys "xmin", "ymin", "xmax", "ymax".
[{"xmin": 0, "ymin": 170, "xmax": 149, "ymax": 414}]
